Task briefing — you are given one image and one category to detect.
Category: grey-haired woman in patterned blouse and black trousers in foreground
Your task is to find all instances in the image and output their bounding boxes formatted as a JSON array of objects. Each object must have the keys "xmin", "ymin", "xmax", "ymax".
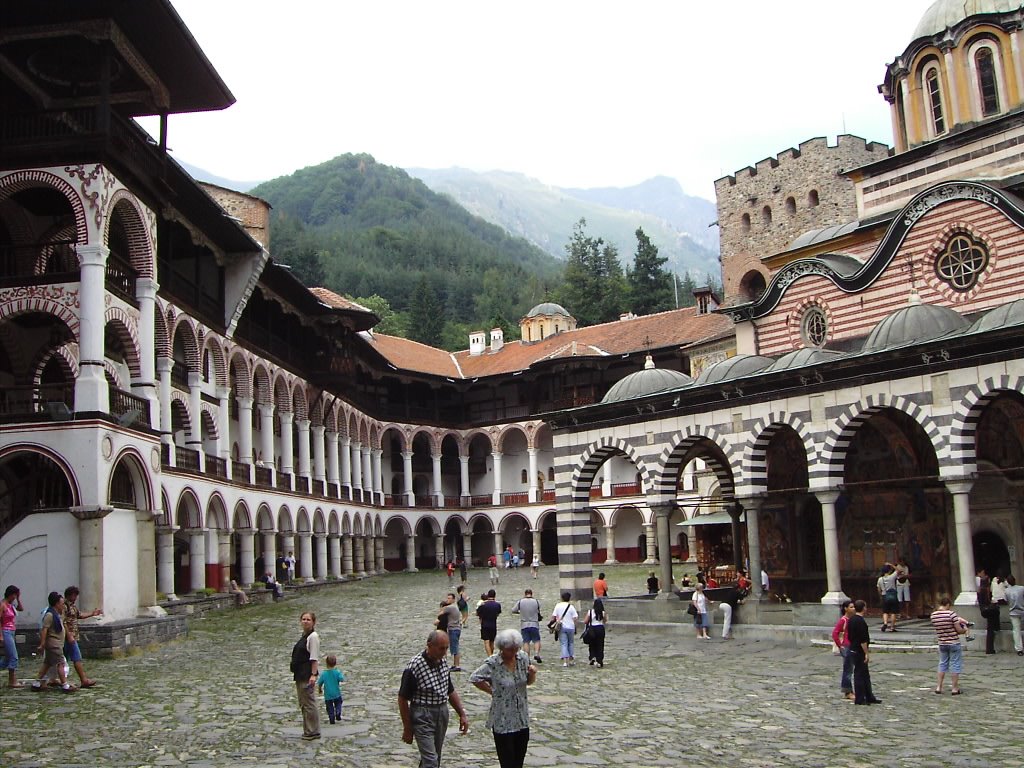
[{"xmin": 469, "ymin": 630, "xmax": 537, "ymax": 768}]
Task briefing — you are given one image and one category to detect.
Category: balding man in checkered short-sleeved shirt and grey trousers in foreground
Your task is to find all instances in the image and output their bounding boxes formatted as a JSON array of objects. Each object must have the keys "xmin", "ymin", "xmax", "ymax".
[{"xmin": 398, "ymin": 630, "xmax": 469, "ymax": 768}]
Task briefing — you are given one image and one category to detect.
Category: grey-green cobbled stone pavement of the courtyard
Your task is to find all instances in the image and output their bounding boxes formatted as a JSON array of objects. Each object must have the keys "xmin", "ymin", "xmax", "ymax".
[{"xmin": 0, "ymin": 567, "xmax": 1024, "ymax": 768}]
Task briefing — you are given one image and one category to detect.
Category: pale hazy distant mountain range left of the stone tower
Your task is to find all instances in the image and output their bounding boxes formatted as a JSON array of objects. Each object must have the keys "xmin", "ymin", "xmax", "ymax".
[{"xmin": 408, "ymin": 168, "xmax": 720, "ymax": 275}]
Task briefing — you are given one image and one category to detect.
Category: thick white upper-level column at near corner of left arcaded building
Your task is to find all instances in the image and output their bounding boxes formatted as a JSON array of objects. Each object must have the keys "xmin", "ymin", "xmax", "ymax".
[{"xmin": 75, "ymin": 246, "xmax": 111, "ymax": 414}]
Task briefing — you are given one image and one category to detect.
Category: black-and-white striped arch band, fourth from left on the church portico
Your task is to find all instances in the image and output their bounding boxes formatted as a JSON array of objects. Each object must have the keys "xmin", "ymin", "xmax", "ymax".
[{"xmin": 811, "ymin": 392, "xmax": 946, "ymax": 486}]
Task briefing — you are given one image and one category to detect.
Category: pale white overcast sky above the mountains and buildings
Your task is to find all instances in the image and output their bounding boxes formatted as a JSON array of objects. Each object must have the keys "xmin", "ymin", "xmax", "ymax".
[{"xmin": 143, "ymin": 0, "xmax": 932, "ymax": 200}]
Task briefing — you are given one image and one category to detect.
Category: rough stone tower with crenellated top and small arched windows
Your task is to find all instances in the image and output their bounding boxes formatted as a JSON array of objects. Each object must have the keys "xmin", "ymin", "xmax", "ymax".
[{"xmin": 715, "ymin": 134, "xmax": 890, "ymax": 302}]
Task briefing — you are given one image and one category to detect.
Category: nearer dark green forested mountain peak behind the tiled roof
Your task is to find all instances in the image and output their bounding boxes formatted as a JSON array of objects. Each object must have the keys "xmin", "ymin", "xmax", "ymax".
[{"xmin": 251, "ymin": 155, "xmax": 572, "ymax": 348}]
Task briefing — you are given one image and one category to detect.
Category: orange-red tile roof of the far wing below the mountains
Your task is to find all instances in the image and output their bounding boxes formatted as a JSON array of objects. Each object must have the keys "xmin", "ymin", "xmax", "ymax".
[{"xmin": 367, "ymin": 307, "xmax": 733, "ymax": 379}]
